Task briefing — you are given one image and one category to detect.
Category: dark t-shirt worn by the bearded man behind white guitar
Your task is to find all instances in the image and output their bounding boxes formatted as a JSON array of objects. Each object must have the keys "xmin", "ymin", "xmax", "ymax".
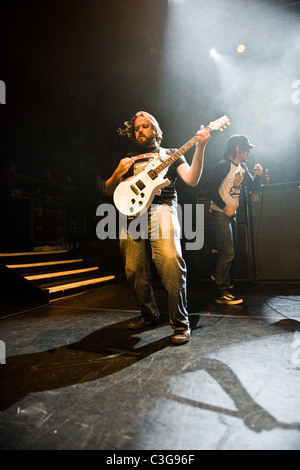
[{"xmin": 124, "ymin": 147, "xmax": 186, "ymax": 205}]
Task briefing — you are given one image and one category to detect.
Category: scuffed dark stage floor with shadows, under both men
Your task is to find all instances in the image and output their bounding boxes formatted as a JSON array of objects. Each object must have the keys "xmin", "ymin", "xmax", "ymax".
[{"xmin": 0, "ymin": 282, "xmax": 300, "ymax": 451}]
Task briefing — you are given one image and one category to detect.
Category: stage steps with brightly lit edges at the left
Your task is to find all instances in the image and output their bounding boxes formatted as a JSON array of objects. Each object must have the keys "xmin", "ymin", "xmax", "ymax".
[{"xmin": 0, "ymin": 250, "xmax": 115, "ymax": 303}]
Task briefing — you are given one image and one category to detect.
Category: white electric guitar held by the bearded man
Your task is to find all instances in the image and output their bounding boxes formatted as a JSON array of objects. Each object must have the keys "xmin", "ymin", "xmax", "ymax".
[{"xmin": 113, "ymin": 116, "xmax": 230, "ymax": 217}]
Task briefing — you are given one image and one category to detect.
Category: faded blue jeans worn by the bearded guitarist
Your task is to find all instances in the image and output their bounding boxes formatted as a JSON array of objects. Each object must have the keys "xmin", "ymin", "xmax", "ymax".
[{"xmin": 120, "ymin": 204, "xmax": 189, "ymax": 329}]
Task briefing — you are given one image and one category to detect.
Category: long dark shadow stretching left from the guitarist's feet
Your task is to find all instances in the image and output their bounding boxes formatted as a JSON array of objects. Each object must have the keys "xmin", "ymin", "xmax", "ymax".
[{"xmin": 0, "ymin": 320, "xmax": 170, "ymax": 411}]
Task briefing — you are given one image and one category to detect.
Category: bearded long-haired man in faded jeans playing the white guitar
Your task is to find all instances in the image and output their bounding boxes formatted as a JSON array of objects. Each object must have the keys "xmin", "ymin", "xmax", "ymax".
[{"xmin": 106, "ymin": 111, "xmax": 210, "ymax": 344}]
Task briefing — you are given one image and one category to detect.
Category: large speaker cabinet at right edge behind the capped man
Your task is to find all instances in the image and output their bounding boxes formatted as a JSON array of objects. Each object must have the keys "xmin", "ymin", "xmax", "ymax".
[{"xmin": 249, "ymin": 182, "xmax": 300, "ymax": 281}]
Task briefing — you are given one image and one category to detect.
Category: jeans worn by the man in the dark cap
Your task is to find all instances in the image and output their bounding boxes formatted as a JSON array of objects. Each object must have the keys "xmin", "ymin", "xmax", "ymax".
[{"xmin": 210, "ymin": 211, "xmax": 237, "ymax": 295}]
